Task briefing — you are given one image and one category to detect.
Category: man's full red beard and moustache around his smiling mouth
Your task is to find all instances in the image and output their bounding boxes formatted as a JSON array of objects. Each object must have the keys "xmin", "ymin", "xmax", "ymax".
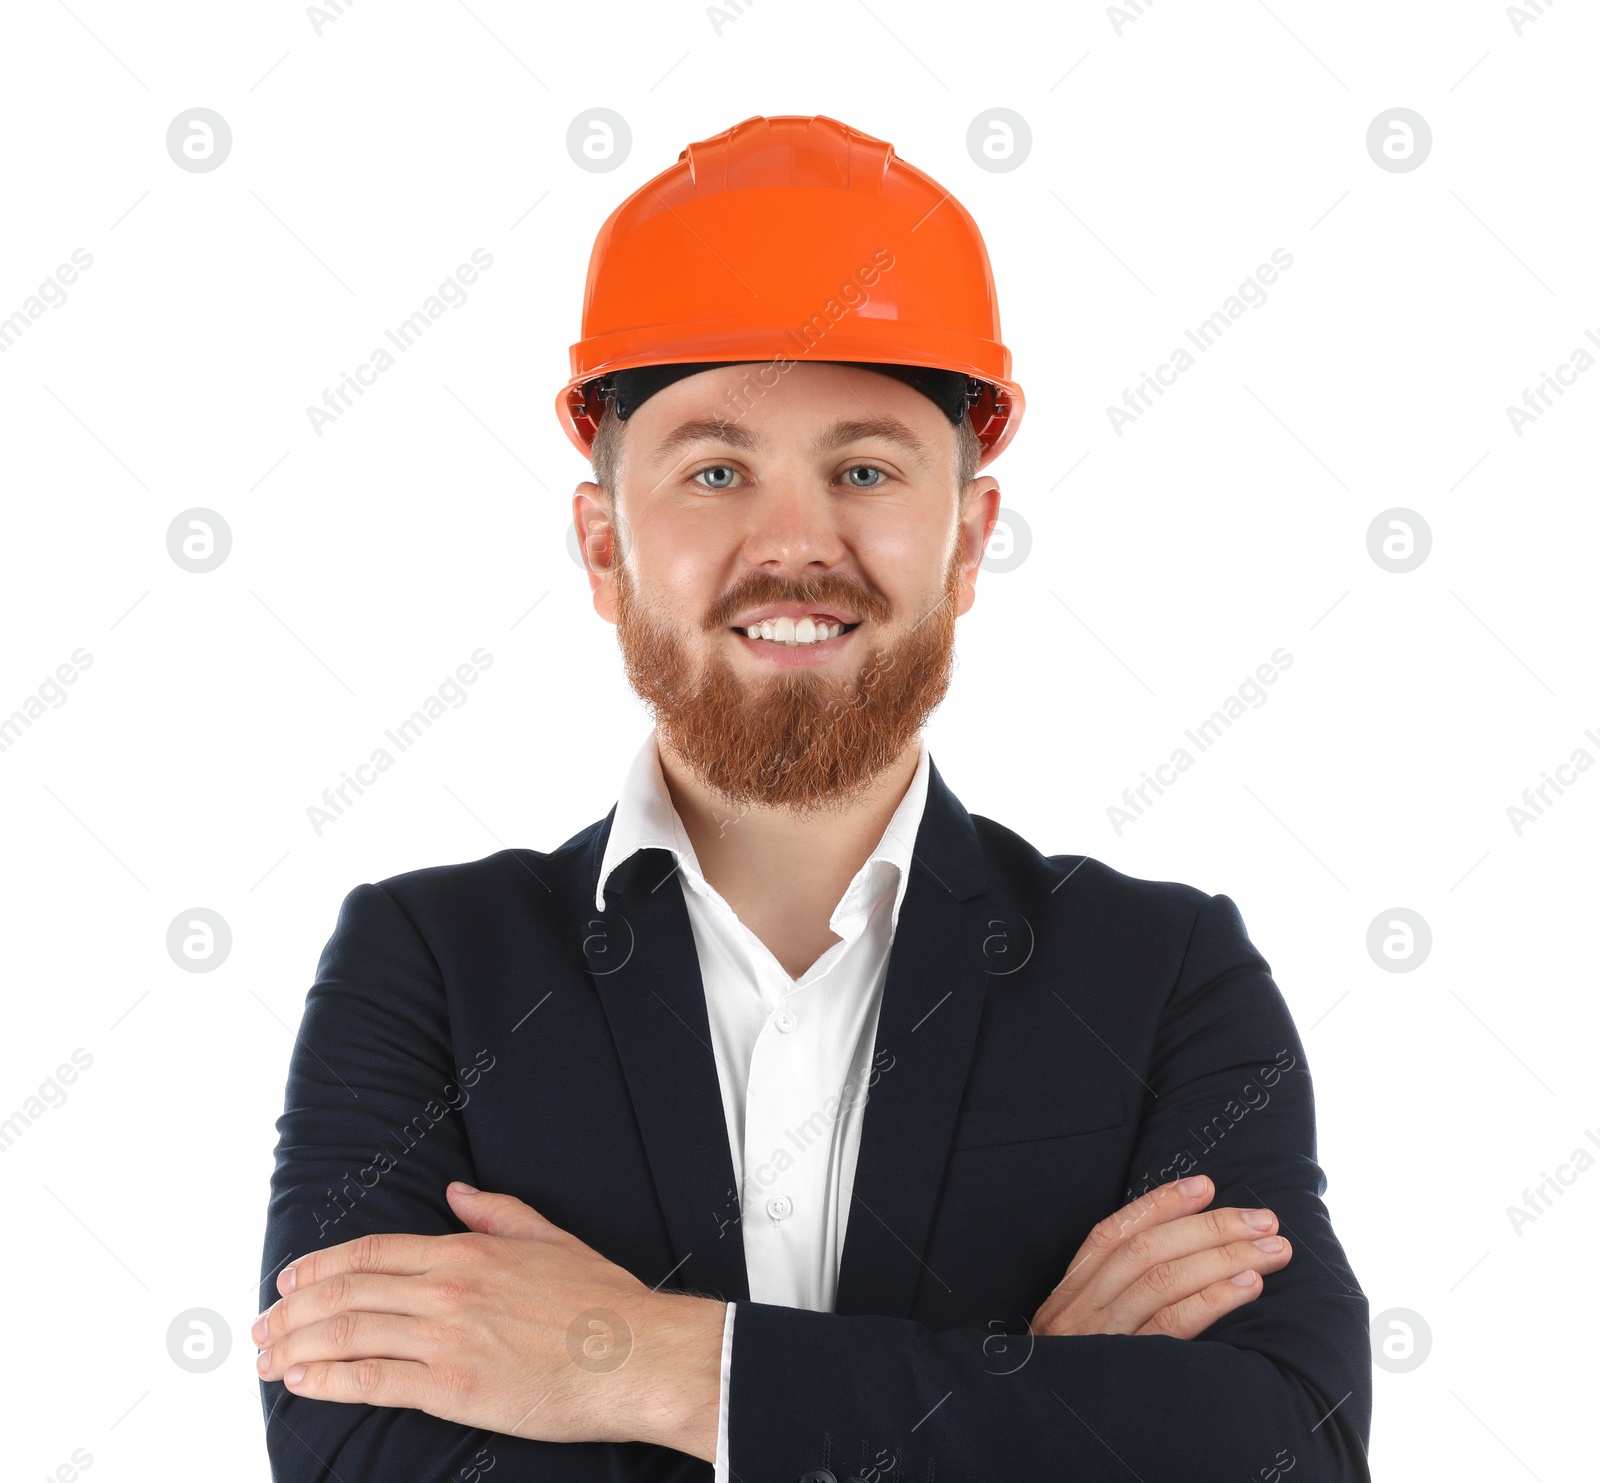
[{"xmin": 618, "ymin": 552, "xmax": 960, "ymax": 814}]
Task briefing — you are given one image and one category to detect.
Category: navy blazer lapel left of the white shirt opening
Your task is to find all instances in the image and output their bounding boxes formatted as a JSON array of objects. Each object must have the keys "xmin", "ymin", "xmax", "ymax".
[{"xmin": 584, "ymin": 821, "xmax": 750, "ymax": 1301}]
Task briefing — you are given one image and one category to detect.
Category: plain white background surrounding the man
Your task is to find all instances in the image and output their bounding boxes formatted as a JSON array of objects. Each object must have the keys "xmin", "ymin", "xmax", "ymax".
[{"xmin": 0, "ymin": 0, "xmax": 1600, "ymax": 1480}]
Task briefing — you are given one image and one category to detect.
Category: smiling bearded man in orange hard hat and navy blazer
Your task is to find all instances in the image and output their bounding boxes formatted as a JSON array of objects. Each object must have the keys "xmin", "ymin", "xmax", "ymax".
[{"xmin": 254, "ymin": 118, "xmax": 1371, "ymax": 1483}]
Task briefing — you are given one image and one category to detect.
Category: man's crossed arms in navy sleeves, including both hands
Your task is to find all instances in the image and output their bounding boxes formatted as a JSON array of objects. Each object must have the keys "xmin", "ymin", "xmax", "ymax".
[{"xmin": 258, "ymin": 886, "xmax": 1371, "ymax": 1483}]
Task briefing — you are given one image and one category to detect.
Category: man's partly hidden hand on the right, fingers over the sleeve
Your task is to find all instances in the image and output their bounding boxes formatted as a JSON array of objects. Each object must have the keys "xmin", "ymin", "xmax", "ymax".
[{"xmin": 1032, "ymin": 1174, "xmax": 1293, "ymax": 1339}]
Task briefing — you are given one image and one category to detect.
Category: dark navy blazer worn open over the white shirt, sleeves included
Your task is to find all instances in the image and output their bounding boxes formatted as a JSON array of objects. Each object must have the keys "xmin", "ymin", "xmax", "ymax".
[{"xmin": 261, "ymin": 768, "xmax": 1371, "ymax": 1483}]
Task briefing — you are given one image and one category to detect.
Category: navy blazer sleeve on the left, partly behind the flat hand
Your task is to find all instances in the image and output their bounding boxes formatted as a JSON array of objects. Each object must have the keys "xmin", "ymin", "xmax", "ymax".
[{"xmin": 261, "ymin": 885, "xmax": 712, "ymax": 1483}]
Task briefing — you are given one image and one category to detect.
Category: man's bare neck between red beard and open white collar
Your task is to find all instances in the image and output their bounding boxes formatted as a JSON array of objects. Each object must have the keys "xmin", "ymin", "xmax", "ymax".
[{"xmin": 658, "ymin": 738, "xmax": 922, "ymax": 977}]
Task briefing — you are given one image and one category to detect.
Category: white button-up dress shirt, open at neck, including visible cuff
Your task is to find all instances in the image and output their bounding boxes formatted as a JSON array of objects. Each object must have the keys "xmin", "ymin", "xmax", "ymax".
[{"xmin": 595, "ymin": 731, "xmax": 928, "ymax": 1483}]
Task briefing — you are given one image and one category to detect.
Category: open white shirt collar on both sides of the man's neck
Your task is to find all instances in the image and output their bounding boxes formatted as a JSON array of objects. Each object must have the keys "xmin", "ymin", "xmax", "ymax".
[{"xmin": 595, "ymin": 731, "xmax": 930, "ymax": 936}]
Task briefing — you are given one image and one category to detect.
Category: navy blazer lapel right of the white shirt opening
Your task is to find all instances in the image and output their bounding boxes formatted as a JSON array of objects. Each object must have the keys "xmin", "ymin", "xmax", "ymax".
[{"xmin": 834, "ymin": 761, "xmax": 989, "ymax": 1318}]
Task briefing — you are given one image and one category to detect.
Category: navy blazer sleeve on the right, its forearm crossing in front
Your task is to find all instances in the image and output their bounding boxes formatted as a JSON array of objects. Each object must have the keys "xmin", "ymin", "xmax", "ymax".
[{"xmin": 728, "ymin": 896, "xmax": 1371, "ymax": 1483}]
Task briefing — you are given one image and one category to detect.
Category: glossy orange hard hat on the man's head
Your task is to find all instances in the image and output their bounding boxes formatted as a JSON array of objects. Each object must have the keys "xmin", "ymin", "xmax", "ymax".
[{"xmin": 555, "ymin": 114, "xmax": 1022, "ymax": 467}]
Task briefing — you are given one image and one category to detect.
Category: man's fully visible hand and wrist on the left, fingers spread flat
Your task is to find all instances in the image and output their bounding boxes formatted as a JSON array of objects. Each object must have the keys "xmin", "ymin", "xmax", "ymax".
[{"xmin": 251, "ymin": 1184, "xmax": 726, "ymax": 1462}]
